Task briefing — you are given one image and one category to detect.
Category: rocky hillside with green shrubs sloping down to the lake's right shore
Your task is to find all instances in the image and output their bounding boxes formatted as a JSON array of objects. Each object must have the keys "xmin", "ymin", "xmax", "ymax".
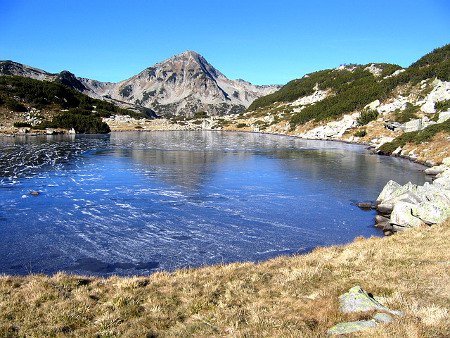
[{"xmin": 221, "ymin": 45, "xmax": 450, "ymax": 164}]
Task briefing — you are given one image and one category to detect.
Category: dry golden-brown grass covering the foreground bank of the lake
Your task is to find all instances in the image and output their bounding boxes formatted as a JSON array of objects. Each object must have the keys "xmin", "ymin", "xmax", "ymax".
[{"xmin": 0, "ymin": 221, "xmax": 450, "ymax": 337}]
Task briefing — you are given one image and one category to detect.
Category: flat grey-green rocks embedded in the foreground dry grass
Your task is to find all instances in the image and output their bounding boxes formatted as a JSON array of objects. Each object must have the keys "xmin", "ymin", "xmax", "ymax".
[{"xmin": 328, "ymin": 285, "xmax": 403, "ymax": 335}]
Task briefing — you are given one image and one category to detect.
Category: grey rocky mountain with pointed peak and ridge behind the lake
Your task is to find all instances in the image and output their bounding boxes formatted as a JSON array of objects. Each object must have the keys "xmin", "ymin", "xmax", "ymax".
[{"xmin": 0, "ymin": 51, "xmax": 279, "ymax": 116}]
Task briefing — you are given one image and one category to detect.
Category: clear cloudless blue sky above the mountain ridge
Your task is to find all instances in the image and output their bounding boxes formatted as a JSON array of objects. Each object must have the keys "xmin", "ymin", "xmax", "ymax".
[{"xmin": 0, "ymin": 0, "xmax": 450, "ymax": 84}]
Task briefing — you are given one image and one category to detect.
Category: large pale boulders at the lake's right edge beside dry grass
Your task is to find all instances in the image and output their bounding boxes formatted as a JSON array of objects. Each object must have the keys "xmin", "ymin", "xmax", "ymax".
[{"xmin": 375, "ymin": 157, "xmax": 450, "ymax": 235}]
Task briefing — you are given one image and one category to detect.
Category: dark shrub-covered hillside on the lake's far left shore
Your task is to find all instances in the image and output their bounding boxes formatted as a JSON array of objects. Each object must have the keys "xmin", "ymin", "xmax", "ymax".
[{"xmin": 0, "ymin": 75, "xmax": 143, "ymax": 133}]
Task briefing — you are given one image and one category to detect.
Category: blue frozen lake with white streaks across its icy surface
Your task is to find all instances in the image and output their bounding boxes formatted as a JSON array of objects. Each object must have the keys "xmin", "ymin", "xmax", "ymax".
[{"xmin": 0, "ymin": 132, "xmax": 425, "ymax": 276}]
